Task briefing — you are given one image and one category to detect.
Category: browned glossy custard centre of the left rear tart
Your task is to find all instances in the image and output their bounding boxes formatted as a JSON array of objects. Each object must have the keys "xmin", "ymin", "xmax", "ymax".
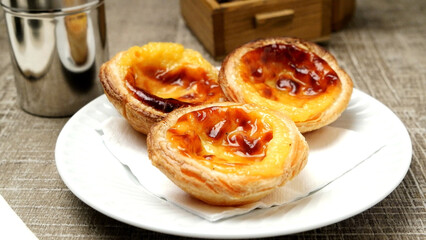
[{"xmin": 125, "ymin": 66, "xmax": 224, "ymax": 113}]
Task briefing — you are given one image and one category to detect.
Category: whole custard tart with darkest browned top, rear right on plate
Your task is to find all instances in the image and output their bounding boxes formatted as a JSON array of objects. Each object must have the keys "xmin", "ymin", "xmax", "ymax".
[{"xmin": 219, "ymin": 37, "xmax": 353, "ymax": 132}]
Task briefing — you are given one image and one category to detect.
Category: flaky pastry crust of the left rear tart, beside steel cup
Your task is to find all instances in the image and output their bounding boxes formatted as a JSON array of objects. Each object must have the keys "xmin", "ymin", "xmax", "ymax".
[{"xmin": 99, "ymin": 43, "xmax": 224, "ymax": 134}]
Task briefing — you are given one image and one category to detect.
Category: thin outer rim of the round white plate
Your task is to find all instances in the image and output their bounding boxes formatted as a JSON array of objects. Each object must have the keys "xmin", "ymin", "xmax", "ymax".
[{"xmin": 55, "ymin": 88, "xmax": 412, "ymax": 239}]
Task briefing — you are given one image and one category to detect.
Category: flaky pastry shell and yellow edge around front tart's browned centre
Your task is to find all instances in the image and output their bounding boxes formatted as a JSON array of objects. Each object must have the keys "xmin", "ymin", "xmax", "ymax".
[{"xmin": 147, "ymin": 102, "xmax": 308, "ymax": 206}]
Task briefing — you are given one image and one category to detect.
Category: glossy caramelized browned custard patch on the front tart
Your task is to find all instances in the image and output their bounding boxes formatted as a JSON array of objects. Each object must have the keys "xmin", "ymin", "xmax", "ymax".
[{"xmin": 167, "ymin": 106, "xmax": 273, "ymax": 170}]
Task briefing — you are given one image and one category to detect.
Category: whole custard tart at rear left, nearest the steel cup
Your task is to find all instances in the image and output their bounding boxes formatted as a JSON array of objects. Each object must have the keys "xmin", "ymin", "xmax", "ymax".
[{"xmin": 99, "ymin": 42, "xmax": 225, "ymax": 134}]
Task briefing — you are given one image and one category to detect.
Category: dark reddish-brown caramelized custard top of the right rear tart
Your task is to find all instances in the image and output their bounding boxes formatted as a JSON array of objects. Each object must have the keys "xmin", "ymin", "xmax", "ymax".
[{"xmin": 240, "ymin": 44, "xmax": 340, "ymax": 100}]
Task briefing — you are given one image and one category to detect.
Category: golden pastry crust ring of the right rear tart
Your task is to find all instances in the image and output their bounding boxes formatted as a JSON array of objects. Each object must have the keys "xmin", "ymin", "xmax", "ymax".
[{"xmin": 219, "ymin": 37, "xmax": 353, "ymax": 133}]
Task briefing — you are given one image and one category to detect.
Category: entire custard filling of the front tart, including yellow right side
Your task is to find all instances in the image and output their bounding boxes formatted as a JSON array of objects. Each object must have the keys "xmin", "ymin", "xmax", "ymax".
[{"xmin": 167, "ymin": 106, "xmax": 292, "ymax": 176}]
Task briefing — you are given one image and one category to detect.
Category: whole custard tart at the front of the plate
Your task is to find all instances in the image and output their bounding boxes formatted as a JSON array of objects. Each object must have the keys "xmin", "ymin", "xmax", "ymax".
[{"xmin": 147, "ymin": 102, "xmax": 308, "ymax": 206}]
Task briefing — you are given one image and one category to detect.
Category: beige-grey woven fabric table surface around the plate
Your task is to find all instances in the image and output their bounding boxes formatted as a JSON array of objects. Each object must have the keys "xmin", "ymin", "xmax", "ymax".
[{"xmin": 0, "ymin": 0, "xmax": 426, "ymax": 239}]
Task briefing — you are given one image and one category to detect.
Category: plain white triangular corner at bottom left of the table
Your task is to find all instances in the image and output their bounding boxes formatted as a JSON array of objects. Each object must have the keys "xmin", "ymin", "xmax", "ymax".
[{"xmin": 0, "ymin": 195, "xmax": 37, "ymax": 240}]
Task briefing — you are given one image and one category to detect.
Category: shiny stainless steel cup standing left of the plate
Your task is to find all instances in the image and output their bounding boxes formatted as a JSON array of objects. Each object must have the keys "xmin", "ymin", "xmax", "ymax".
[{"xmin": 1, "ymin": 0, "xmax": 108, "ymax": 117}]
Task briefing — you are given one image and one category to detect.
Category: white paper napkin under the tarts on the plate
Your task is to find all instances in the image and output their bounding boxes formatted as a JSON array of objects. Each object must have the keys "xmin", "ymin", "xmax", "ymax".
[{"xmin": 99, "ymin": 117, "xmax": 383, "ymax": 221}]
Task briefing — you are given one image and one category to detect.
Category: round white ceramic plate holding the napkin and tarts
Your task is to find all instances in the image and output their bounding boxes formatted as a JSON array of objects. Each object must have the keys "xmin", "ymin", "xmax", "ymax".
[{"xmin": 55, "ymin": 89, "xmax": 412, "ymax": 238}]
